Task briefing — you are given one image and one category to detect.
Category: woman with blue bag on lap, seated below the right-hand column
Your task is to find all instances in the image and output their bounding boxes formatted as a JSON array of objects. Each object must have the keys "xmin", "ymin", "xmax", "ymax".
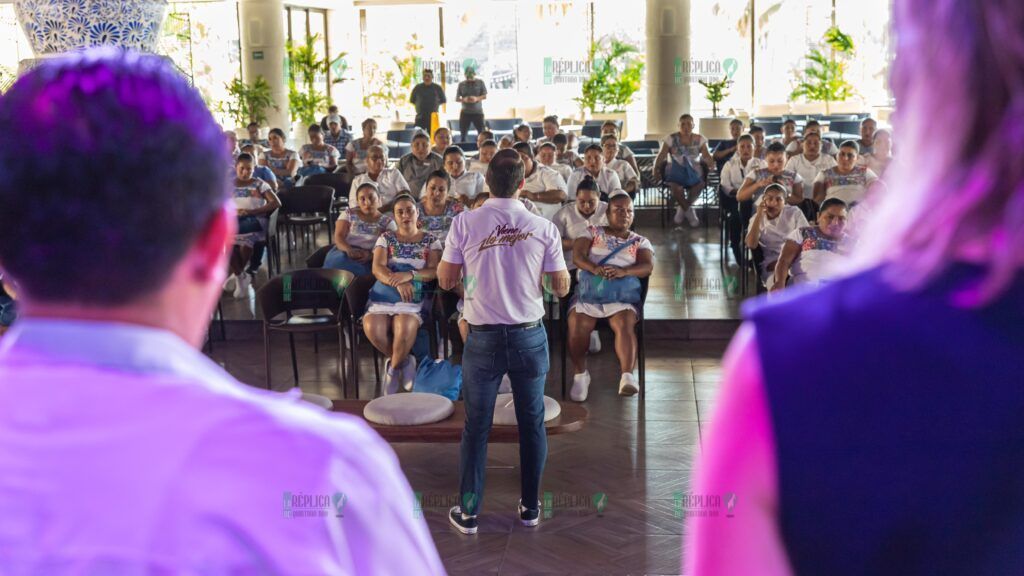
[{"xmin": 654, "ymin": 114, "xmax": 715, "ymax": 227}]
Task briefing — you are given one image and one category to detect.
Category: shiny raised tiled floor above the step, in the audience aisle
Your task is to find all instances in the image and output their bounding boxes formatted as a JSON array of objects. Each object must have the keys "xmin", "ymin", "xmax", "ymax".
[{"xmin": 221, "ymin": 215, "xmax": 741, "ymax": 320}]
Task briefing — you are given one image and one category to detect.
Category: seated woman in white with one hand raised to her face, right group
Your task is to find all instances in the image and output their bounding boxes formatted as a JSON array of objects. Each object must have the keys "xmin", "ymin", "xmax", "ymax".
[{"xmin": 745, "ymin": 184, "xmax": 810, "ymax": 290}]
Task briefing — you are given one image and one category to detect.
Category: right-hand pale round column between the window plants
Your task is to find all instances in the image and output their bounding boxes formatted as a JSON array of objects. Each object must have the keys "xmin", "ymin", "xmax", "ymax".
[{"xmin": 646, "ymin": 0, "xmax": 690, "ymax": 137}]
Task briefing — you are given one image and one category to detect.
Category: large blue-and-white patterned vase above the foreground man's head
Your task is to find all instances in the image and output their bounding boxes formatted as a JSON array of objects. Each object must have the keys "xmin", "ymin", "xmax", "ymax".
[{"xmin": 14, "ymin": 0, "xmax": 167, "ymax": 57}]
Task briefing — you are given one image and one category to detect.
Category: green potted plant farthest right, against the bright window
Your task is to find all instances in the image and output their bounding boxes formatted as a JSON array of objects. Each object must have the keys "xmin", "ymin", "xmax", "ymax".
[{"xmin": 790, "ymin": 26, "xmax": 855, "ymax": 114}]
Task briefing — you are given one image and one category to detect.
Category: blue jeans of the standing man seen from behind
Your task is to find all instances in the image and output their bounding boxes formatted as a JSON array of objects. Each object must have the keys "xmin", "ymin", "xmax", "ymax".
[{"xmin": 459, "ymin": 325, "xmax": 549, "ymax": 515}]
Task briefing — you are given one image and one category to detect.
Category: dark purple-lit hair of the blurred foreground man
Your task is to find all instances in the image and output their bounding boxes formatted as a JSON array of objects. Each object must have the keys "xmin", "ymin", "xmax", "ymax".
[{"xmin": 0, "ymin": 47, "xmax": 230, "ymax": 306}]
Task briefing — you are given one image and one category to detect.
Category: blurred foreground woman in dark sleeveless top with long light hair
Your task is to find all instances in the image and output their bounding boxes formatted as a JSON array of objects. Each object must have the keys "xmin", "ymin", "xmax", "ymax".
[{"xmin": 684, "ymin": 0, "xmax": 1024, "ymax": 576}]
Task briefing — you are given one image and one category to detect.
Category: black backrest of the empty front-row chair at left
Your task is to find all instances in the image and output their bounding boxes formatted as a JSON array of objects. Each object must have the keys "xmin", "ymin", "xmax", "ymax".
[{"xmin": 256, "ymin": 269, "xmax": 352, "ymax": 322}]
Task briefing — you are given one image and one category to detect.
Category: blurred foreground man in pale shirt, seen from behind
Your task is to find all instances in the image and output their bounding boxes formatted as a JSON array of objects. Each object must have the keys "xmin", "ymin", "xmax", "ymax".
[{"xmin": 0, "ymin": 48, "xmax": 444, "ymax": 574}]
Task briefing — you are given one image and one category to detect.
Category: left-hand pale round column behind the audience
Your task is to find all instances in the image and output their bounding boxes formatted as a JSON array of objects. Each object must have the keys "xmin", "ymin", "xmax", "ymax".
[{"xmin": 239, "ymin": 0, "xmax": 291, "ymax": 130}]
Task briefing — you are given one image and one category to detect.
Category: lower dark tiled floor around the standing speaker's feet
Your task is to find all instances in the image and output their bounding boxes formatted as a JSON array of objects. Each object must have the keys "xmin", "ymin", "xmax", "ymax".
[{"xmin": 205, "ymin": 325, "xmax": 726, "ymax": 575}]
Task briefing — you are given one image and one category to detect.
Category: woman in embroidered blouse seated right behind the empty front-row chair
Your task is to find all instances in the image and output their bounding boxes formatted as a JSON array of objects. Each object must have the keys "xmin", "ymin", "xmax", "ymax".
[{"xmin": 324, "ymin": 182, "xmax": 396, "ymax": 276}]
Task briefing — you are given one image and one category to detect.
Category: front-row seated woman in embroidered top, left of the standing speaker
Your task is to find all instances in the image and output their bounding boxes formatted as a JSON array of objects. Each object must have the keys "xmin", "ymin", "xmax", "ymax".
[{"xmin": 362, "ymin": 195, "xmax": 441, "ymax": 394}]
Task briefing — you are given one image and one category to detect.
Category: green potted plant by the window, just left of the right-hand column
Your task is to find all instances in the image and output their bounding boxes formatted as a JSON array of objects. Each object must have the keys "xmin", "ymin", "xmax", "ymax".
[{"xmin": 573, "ymin": 37, "xmax": 644, "ymax": 137}]
